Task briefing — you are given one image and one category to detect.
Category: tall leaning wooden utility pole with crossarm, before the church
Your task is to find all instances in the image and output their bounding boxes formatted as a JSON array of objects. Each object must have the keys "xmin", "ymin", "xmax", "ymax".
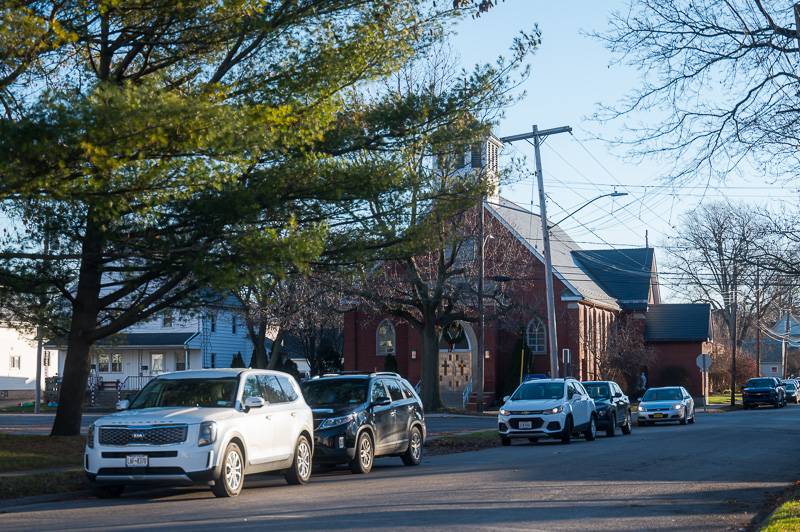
[{"xmin": 500, "ymin": 125, "xmax": 572, "ymax": 378}]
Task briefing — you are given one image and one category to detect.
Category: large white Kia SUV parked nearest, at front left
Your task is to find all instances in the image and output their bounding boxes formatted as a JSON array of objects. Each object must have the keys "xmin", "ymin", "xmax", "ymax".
[{"xmin": 84, "ymin": 369, "xmax": 314, "ymax": 497}]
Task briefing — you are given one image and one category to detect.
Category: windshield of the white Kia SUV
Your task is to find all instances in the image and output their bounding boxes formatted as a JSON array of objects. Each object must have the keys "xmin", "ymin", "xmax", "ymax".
[{"xmin": 130, "ymin": 377, "xmax": 239, "ymax": 409}]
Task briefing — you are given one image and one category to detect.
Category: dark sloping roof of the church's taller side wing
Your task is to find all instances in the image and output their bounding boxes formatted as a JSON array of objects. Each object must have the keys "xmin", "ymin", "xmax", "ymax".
[{"xmin": 572, "ymin": 248, "xmax": 654, "ymax": 311}]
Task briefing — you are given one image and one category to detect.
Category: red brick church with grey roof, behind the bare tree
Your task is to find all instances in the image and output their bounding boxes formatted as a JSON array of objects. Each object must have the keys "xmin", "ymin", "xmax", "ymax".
[{"xmin": 344, "ymin": 138, "xmax": 711, "ymax": 407}]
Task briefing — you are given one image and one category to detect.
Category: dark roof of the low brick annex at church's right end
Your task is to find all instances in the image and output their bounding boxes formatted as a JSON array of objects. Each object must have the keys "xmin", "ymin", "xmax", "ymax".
[{"xmin": 645, "ymin": 303, "xmax": 711, "ymax": 342}]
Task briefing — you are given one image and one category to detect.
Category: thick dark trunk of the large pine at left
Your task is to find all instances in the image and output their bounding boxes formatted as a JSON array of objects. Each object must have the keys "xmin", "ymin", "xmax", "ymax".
[{"xmin": 50, "ymin": 209, "xmax": 103, "ymax": 436}]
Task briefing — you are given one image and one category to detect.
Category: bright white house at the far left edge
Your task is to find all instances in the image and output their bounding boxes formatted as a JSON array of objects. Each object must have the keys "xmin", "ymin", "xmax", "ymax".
[{"xmin": 0, "ymin": 327, "xmax": 43, "ymax": 400}]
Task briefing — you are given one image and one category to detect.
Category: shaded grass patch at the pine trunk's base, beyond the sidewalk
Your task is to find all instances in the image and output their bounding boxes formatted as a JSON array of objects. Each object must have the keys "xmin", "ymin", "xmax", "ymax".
[{"xmin": 0, "ymin": 434, "xmax": 83, "ymax": 473}]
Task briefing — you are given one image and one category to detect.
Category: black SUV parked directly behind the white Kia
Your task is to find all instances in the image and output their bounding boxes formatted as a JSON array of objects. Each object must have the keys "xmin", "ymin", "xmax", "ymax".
[{"xmin": 301, "ymin": 372, "xmax": 426, "ymax": 473}]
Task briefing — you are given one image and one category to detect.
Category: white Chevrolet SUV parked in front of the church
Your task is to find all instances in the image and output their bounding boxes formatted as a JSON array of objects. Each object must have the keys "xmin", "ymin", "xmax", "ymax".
[{"xmin": 497, "ymin": 378, "xmax": 597, "ymax": 445}]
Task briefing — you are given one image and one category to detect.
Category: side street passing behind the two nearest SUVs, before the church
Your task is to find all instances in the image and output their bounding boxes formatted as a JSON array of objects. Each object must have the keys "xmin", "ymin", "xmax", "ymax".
[{"xmin": 0, "ymin": 414, "xmax": 497, "ymax": 434}]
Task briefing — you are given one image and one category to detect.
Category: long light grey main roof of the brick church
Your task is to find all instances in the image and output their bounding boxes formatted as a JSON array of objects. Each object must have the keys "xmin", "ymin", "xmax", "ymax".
[{"xmin": 486, "ymin": 197, "xmax": 620, "ymax": 310}]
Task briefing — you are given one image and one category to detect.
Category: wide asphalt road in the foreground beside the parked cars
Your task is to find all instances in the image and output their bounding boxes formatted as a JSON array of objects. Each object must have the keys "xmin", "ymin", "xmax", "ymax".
[{"xmin": 0, "ymin": 406, "xmax": 800, "ymax": 531}]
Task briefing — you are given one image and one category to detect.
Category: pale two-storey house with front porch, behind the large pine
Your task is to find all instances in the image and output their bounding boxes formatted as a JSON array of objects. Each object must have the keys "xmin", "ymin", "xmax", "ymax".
[{"xmin": 45, "ymin": 298, "xmax": 253, "ymax": 390}]
